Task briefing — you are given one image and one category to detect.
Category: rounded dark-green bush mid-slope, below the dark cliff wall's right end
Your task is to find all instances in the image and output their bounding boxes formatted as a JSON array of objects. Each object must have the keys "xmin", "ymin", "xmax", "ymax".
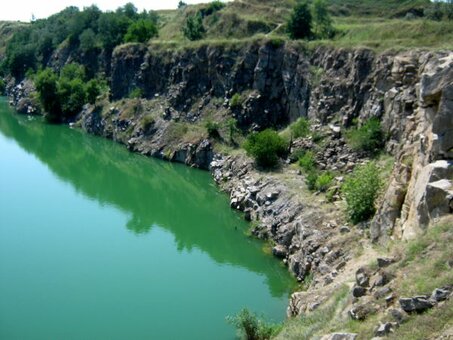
[{"xmin": 244, "ymin": 129, "xmax": 288, "ymax": 168}]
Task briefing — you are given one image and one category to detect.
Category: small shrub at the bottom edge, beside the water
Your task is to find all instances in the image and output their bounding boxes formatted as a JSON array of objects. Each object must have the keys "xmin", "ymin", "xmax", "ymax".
[{"xmin": 227, "ymin": 308, "xmax": 281, "ymax": 340}]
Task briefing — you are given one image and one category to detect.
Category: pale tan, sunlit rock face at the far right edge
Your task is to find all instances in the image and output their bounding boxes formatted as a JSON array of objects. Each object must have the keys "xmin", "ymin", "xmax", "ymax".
[{"xmin": 371, "ymin": 53, "xmax": 453, "ymax": 240}]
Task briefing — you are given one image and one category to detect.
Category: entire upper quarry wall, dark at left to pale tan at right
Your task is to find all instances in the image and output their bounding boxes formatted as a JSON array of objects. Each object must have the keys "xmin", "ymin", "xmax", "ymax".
[{"xmin": 107, "ymin": 43, "xmax": 453, "ymax": 241}]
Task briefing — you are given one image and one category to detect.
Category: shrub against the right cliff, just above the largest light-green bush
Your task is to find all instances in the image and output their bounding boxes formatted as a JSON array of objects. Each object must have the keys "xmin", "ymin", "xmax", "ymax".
[{"xmin": 346, "ymin": 118, "xmax": 384, "ymax": 154}]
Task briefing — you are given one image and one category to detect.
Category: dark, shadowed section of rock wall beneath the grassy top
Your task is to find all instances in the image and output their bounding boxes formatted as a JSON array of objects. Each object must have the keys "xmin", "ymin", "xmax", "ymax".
[{"xmin": 112, "ymin": 43, "xmax": 310, "ymax": 129}]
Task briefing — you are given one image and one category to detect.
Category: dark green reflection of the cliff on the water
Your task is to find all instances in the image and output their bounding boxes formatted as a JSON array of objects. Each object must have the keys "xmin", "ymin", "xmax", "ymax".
[{"xmin": 0, "ymin": 99, "xmax": 294, "ymax": 296}]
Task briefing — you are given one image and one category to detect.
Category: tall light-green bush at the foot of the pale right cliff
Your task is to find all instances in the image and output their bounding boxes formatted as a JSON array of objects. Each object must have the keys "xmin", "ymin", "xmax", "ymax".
[{"xmin": 342, "ymin": 162, "xmax": 381, "ymax": 223}]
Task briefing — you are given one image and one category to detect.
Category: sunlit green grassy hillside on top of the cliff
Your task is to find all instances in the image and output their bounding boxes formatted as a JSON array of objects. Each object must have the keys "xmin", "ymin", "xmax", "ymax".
[{"xmin": 154, "ymin": 0, "xmax": 453, "ymax": 51}]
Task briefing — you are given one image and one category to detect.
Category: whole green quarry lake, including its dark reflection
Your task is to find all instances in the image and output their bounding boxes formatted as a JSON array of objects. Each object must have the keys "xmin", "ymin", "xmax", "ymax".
[{"xmin": 0, "ymin": 98, "xmax": 293, "ymax": 340}]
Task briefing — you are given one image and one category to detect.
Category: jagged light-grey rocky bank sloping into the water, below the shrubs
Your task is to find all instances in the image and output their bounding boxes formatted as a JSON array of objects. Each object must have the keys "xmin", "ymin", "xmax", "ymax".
[{"xmin": 211, "ymin": 156, "xmax": 345, "ymax": 282}]
